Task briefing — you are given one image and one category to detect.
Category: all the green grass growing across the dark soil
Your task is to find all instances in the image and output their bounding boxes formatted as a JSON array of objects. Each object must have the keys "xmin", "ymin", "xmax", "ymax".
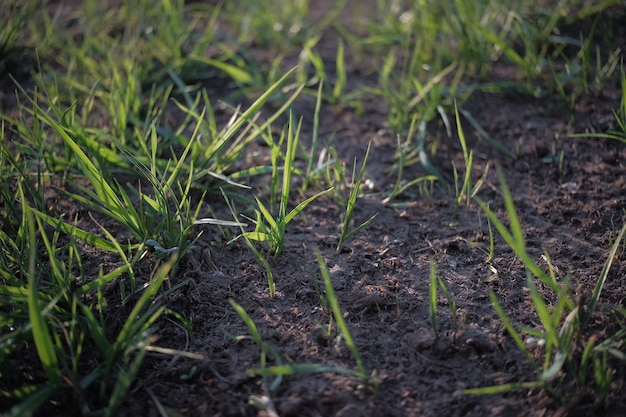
[{"xmin": 0, "ymin": 0, "xmax": 626, "ymax": 415}]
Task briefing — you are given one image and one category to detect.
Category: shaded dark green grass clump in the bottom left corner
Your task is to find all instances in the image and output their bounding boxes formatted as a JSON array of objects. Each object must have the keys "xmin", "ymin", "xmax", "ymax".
[{"xmin": 0, "ymin": 183, "xmax": 183, "ymax": 416}]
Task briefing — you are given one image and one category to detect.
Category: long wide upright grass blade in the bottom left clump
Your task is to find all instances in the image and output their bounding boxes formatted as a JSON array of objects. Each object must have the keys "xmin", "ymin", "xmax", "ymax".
[{"xmin": 22, "ymin": 202, "xmax": 62, "ymax": 387}]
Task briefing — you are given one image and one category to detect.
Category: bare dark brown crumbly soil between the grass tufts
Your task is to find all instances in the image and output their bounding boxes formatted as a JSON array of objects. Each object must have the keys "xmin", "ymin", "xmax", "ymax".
[{"xmin": 1, "ymin": 0, "xmax": 626, "ymax": 417}]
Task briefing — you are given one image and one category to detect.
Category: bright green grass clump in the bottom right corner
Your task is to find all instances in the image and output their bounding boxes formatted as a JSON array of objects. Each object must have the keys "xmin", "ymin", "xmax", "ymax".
[{"xmin": 455, "ymin": 168, "xmax": 626, "ymax": 403}]
